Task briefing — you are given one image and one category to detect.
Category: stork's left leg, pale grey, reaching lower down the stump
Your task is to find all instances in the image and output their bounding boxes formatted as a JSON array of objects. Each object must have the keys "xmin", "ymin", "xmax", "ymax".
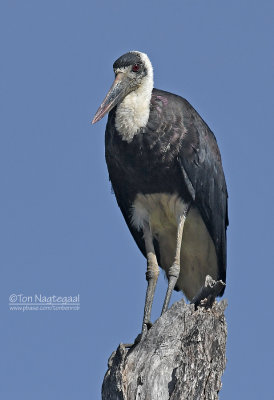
[{"xmin": 141, "ymin": 223, "xmax": 159, "ymax": 339}]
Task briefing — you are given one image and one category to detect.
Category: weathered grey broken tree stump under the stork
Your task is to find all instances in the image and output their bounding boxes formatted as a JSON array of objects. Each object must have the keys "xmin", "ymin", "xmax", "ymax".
[{"xmin": 102, "ymin": 300, "xmax": 227, "ymax": 400}]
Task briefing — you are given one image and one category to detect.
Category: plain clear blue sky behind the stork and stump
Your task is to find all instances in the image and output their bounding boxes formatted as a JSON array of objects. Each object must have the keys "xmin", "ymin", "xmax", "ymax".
[{"xmin": 0, "ymin": 0, "xmax": 274, "ymax": 400}]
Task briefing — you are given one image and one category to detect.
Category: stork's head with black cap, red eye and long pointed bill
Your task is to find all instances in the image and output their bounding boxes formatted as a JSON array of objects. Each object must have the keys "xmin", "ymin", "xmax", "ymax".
[{"xmin": 92, "ymin": 51, "xmax": 153, "ymax": 124}]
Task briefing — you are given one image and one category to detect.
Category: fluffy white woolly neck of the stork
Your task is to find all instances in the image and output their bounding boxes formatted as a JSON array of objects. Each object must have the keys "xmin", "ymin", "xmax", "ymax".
[{"xmin": 115, "ymin": 53, "xmax": 153, "ymax": 143}]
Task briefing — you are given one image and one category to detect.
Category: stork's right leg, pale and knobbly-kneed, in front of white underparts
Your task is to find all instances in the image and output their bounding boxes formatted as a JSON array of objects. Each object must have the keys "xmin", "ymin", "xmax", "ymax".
[{"xmin": 161, "ymin": 205, "xmax": 189, "ymax": 315}]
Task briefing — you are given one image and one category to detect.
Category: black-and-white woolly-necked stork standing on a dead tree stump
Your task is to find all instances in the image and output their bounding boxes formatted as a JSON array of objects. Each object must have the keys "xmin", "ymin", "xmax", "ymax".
[{"xmin": 92, "ymin": 51, "xmax": 228, "ymax": 337}]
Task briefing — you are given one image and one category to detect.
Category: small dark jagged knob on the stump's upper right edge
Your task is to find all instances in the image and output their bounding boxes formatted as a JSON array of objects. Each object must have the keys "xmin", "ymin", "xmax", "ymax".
[{"xmin": 191, "ymin": 275, "xmax": 225, "ymax": 309}]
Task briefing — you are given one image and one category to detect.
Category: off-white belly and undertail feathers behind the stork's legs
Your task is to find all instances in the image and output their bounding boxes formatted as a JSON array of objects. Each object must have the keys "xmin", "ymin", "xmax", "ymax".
[{"xmin": 132, "ymin": 193, "xmax": 218, "ymax": 299}]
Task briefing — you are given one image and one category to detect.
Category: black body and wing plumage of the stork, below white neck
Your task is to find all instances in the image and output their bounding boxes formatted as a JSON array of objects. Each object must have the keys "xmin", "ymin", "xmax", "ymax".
[{"xmin": 105, "ymin": 89, "xmax": 228, "ymax": 292}]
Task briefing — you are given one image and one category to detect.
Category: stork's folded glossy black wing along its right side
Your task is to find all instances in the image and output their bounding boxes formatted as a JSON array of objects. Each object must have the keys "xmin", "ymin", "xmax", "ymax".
[{"xmin": 152, "ymin": 89, "xmax": 228, "ymax": 294}]
